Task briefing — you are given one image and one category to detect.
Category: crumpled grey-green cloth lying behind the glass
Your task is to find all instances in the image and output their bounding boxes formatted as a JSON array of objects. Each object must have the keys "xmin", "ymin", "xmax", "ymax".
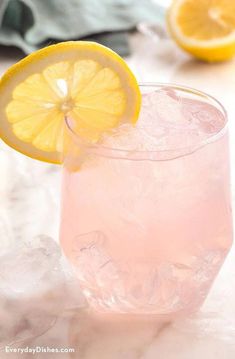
[{"xmin": 0, "ymin": 0, "xmax": 163, "ymax": 55}]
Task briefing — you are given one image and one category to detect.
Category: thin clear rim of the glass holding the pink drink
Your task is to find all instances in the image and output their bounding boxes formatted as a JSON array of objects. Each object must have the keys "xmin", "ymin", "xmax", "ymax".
[{"xmin": 65, "ymin": 82, "xmax": 228, "ymax": 161}]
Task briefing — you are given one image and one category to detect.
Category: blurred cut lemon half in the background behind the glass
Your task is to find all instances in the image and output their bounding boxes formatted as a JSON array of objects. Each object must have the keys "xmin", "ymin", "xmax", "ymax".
[{"xmin": 167, "ymin": 0, "xmax": 235, "ymax": 62}]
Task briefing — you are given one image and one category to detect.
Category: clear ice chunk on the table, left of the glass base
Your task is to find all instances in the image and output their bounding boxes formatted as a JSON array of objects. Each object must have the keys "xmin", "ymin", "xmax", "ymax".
[{"xmin": 0, "ymin": 236, "xmax": 60, "ymax": 298}]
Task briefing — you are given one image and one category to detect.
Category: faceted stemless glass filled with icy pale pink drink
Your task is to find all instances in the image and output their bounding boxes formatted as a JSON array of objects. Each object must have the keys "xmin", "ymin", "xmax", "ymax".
[{"xmin": 61, "ymin": 85, "xmax": 232, "ymax": 317}]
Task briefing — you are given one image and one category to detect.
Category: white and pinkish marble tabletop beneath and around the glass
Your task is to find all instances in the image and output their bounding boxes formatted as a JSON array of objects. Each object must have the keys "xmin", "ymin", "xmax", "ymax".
[{"xmin": 0, "ymin": 33, "xmax": 235, "ymax": 359}]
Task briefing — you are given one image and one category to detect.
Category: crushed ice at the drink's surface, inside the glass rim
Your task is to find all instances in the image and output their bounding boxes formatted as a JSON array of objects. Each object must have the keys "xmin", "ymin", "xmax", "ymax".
[{"xmin": 102, "ymin": 88, "xmax": 225, "ymax": 151}]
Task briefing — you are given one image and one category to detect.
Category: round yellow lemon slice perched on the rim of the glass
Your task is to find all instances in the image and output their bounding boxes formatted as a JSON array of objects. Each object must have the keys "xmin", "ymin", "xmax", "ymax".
[{"xmin": 0, "ymin": 41, "xmax": 141, "ymax": 163}]
